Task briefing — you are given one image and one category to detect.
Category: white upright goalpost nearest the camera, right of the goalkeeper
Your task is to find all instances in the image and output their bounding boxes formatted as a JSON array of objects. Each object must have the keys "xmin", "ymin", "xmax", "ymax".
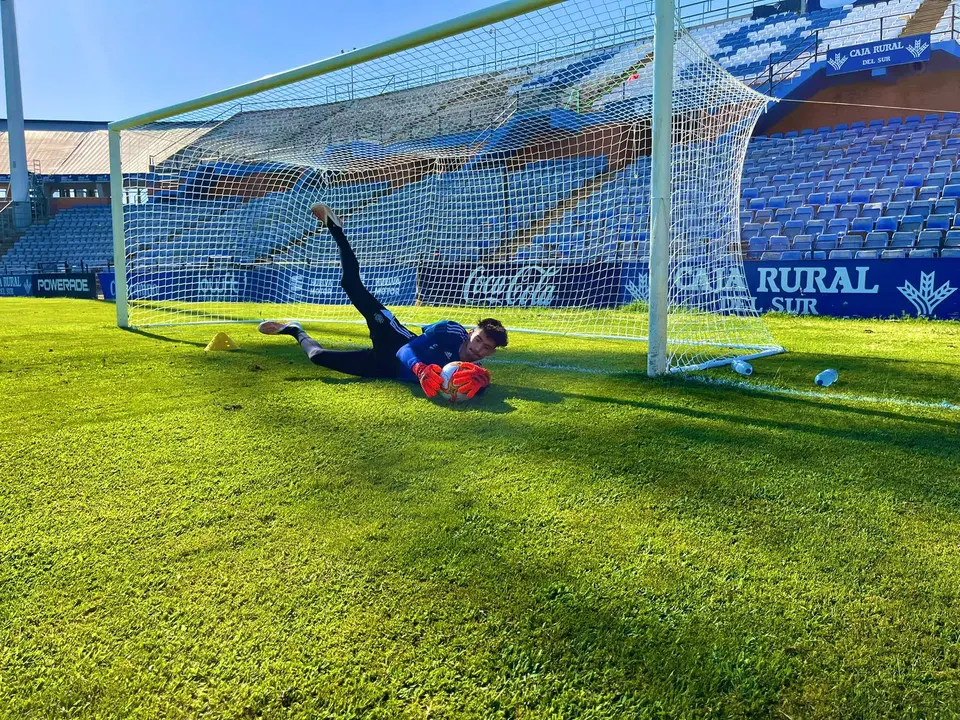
[{"xmin": 647, "ymin": 0, "xmax": 675, "ymax": 377}]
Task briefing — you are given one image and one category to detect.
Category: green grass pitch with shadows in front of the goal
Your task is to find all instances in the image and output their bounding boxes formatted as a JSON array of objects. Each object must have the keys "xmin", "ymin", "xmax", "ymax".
[{"xmin": 0, "ymin": 300, "xmax": 960, "ymax": 720}]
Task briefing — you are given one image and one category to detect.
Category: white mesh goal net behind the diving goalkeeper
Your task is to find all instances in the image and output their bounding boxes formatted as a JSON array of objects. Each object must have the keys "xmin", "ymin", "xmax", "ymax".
[{"xmin": 107, "ymin": 0, "xmax": 779, "ymax": 369}]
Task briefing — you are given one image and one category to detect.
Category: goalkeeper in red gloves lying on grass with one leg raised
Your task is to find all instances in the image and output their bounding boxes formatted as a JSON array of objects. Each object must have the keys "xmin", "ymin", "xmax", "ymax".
[{"xmin": 260, "ymin": 203, "xmax": 507, "ymax": 398}]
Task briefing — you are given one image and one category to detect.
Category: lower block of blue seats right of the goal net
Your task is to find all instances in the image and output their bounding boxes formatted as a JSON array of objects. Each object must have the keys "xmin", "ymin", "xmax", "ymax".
[{"xmin": 740, "ymin": 113, "xmax": 960, "ymax": 259}]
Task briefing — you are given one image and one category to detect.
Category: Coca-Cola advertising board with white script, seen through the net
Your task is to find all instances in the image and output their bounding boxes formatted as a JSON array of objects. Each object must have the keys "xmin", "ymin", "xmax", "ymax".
[{"xmin": 417, "ymin": 262, "xmax": 621, "ymax": 308}]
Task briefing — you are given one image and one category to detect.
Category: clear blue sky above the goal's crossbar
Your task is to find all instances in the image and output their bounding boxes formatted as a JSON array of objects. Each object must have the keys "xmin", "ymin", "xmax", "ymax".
[{"xmin": 0, "ymin": 0, "xmax": 493, "ymax": 120}]
